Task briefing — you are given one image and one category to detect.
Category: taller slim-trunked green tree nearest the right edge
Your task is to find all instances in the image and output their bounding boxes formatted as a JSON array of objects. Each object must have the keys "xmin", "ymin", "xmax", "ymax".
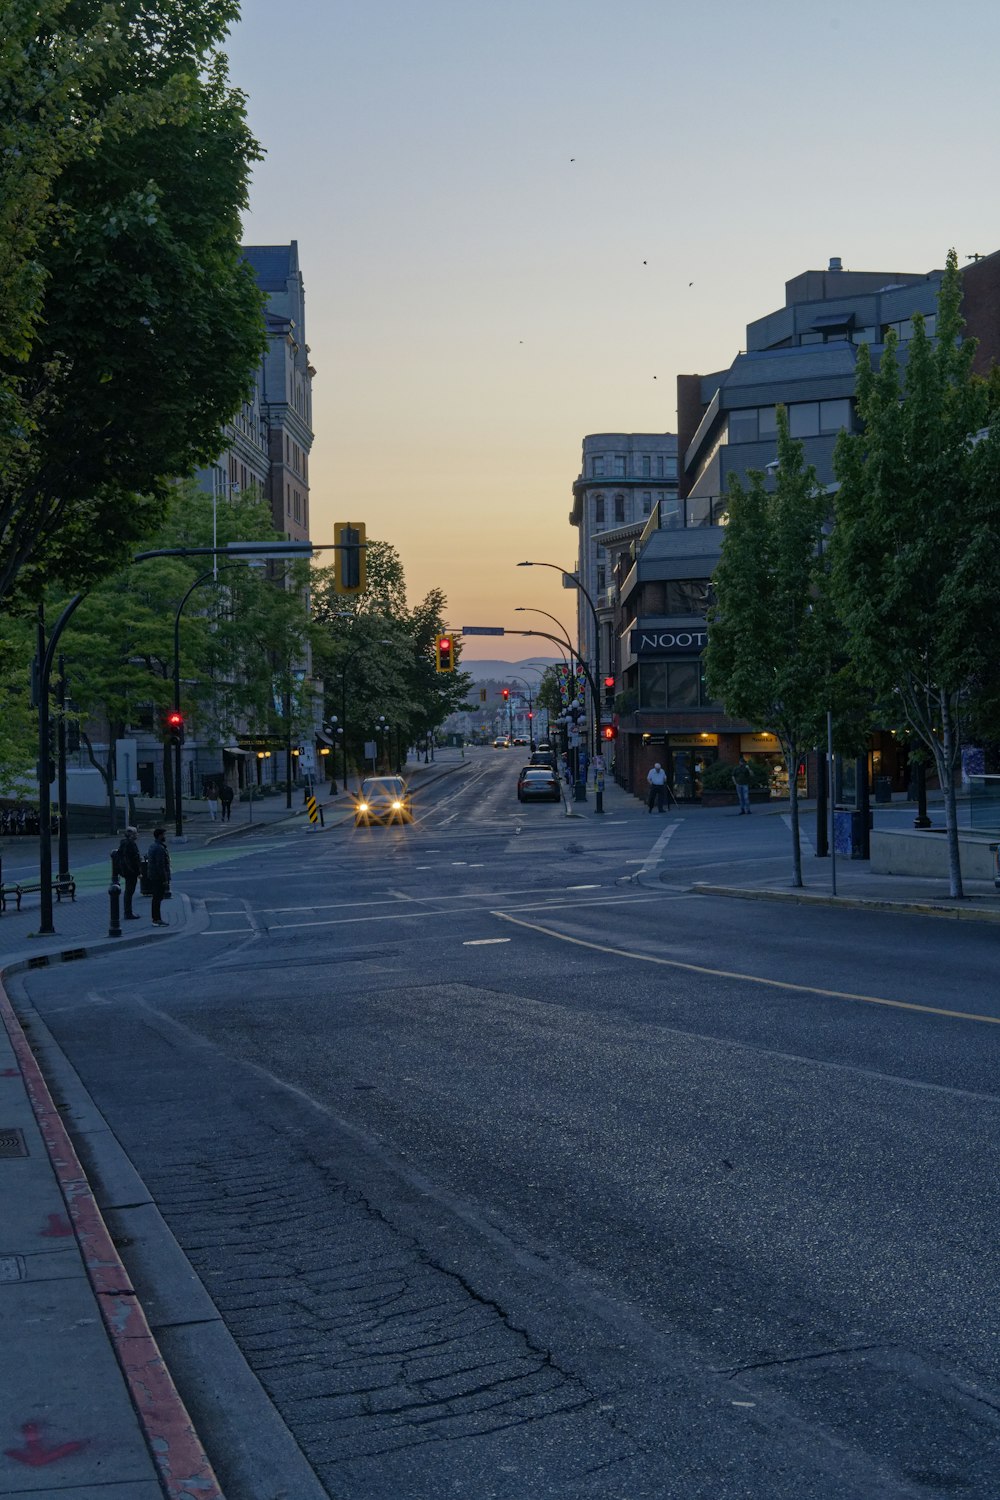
[{"xmin": 831, "ymin": 251, "xmax": 1000, "ymax": 897}]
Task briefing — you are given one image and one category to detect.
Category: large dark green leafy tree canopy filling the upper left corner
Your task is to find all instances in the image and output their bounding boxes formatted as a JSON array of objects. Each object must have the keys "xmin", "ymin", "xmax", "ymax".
[{"xmin": 0, "ymin": 0, "xmax": 265, "ymax": 602}]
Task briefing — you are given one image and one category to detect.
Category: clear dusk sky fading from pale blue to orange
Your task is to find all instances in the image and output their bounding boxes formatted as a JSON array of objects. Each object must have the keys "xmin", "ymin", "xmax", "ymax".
[{"xmin": 226, "ymin": 0, "xmax": 1000, "ymax": 660}]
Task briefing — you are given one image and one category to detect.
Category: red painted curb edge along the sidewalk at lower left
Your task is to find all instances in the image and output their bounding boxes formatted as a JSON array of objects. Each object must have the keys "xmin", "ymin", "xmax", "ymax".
[{"xmin": 0, "ymin": 984, "xmax": 225, "ymax": 1500}]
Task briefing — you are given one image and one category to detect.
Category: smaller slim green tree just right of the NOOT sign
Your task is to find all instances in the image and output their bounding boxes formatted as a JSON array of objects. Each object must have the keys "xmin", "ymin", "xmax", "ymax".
[{"xmin": 705, "ymin": 407, "xmax": 835, "ymax": 887}]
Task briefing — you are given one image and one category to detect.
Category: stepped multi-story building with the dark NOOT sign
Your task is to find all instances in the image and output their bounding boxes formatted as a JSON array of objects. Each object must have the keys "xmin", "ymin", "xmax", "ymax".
[{"xmin": 605, "ymin": 254, "xmax": 1000, "ymax": 797}]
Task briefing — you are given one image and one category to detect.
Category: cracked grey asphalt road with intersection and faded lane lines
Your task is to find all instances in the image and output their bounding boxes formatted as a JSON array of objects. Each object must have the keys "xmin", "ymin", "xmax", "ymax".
[{"xmin": 13, "ymin": 752, "xmax": 1000, "ymax": 1500}]
